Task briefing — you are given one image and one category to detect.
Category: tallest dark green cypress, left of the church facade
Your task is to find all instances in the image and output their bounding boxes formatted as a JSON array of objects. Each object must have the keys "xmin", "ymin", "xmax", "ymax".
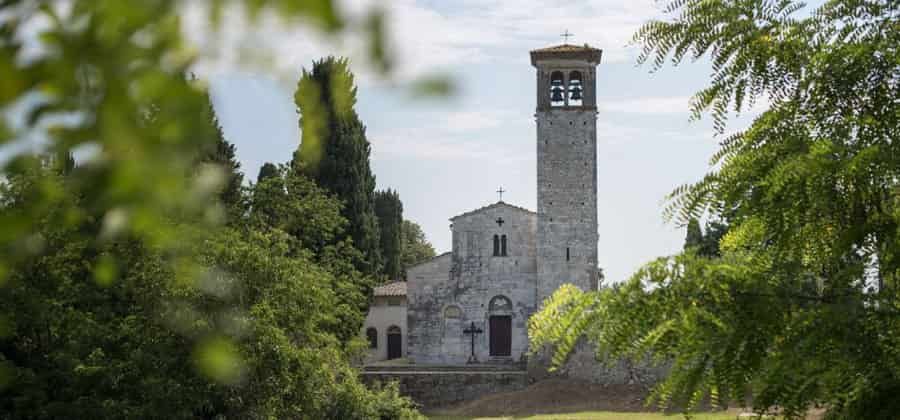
[{"xmin": 291, "ymin": 57, "xmax": 382, "ymax": 276}]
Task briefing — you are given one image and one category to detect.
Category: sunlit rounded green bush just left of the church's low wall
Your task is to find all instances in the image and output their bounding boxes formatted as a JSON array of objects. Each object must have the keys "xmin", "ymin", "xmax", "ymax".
[{"xmin": 195, "ymin": 230, "xmax": 420, "ymax": 419}]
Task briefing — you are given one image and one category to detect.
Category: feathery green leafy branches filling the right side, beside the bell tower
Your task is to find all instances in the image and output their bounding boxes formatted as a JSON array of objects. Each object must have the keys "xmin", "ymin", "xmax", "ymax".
[{"xmin": 531, "ymin": 0, "xmax": 900, "ymax": 419}]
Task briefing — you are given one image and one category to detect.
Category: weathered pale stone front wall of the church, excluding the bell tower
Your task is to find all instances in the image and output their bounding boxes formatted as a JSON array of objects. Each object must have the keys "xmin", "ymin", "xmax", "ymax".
[{"xmin": 407, "ymin": 202, "xmax": 537, "ymax": 364}]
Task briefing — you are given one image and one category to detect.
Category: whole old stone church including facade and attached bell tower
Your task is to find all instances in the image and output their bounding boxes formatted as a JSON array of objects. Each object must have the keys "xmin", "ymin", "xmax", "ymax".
[{"xmin": 364, "ymin": 44, "xmax": 602, "ymax": 365}]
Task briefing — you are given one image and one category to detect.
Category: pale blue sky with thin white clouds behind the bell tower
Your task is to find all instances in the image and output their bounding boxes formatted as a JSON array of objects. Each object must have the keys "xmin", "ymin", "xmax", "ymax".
[{"xmin": 185, "ymin": 0, "xmax": 768, "ymax": 282}]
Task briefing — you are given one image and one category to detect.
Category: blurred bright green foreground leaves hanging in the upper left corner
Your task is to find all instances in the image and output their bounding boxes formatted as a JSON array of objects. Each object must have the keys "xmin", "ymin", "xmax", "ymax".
[{"xmin": 0, "ymin": 0, "xmax": 389, "ymax": 306}]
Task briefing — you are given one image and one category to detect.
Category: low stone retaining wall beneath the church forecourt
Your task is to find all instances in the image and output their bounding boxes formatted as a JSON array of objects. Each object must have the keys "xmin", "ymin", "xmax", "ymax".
[{"xmin": 362, "ymin": 365, "xmax": 528, "ymax": 409}]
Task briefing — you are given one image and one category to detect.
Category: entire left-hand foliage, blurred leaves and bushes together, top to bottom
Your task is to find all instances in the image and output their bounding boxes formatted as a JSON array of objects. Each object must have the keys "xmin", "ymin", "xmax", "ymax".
[{"xmin": 0, "ymin": 0, "xmax": 418, "ymax": 419}]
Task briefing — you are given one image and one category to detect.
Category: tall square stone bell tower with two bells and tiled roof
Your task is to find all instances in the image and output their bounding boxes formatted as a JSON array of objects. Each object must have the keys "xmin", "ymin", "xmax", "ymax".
[{"xmin": 531, "ymin": 44, "xmax": 602, "ymax": 306}]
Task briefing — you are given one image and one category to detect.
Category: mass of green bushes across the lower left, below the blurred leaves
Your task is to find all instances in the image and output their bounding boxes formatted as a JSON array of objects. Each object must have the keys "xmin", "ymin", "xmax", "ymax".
[{"xmin": 0, "ymin": 158, "xmax": 418, "ymax": 419}]
